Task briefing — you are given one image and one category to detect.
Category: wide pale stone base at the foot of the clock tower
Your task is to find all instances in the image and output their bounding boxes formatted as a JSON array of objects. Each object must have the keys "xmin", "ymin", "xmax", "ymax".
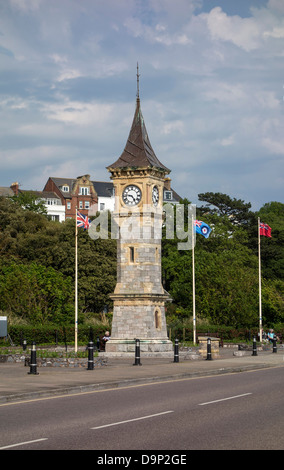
[{"xmin": 105, "ymin": 338, "xmax": 173, "ymax": 358}]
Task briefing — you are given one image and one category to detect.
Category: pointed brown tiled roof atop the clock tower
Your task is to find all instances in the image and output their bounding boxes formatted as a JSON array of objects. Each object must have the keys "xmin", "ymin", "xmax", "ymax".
[{"xmin": 108, "ymin": 97, "xmax": 170, "ymax": 173}]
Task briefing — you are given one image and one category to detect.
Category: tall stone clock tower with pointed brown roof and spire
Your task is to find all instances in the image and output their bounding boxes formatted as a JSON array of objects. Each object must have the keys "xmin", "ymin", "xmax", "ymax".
[{"xmin": 106, "ymin": 67, "xmax": 173, "ymax": 354}]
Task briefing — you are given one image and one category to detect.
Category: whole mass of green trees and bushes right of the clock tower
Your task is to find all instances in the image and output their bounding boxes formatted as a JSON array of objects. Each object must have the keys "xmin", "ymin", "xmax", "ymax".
[{"xmin": 162, "ymin": 193, "xmax": 284, "ymax": 327}]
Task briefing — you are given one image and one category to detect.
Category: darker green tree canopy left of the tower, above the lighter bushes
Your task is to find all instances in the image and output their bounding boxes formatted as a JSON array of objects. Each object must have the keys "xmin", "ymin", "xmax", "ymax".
[{"xmin": 0, "ymin": 198, "xmax": 116, "ymax": 320}]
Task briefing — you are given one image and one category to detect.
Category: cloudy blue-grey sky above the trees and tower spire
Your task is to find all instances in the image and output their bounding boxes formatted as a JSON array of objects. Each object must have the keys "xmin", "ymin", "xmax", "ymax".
[{"xmin": 0, "ymin": 0, "xmax": 284, "ymax": 210}]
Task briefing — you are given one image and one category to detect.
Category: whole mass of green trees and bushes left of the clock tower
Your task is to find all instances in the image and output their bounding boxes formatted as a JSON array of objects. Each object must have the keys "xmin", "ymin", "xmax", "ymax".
[{"xmin": 0, "ymin": 198, "xmax": 116, "ymax": 323}]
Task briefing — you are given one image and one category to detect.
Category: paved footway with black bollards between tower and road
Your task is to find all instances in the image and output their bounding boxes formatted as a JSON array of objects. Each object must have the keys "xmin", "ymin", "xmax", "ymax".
[{"xmin": 0, "ymin": 345, "xmax": 284, "ymax": 405}]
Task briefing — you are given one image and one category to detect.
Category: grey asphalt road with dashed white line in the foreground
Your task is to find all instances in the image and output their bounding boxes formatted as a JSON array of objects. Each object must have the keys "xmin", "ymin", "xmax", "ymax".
[{"xmin": 0, "ymin": 368, "xmax": 284, "ymax": 452}]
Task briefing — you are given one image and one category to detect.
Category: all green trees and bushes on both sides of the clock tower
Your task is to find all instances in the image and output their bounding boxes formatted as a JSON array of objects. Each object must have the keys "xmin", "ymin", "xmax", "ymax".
[{"xmin": 0, "ymin": 193, "xmax": 284, "ymax": 330}]
